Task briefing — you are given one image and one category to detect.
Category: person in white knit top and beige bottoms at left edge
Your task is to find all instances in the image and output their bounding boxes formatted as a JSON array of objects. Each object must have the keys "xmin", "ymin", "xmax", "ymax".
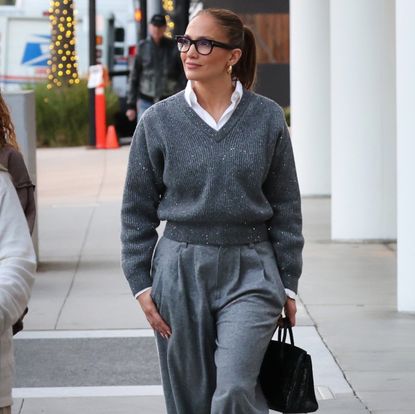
[{"xmin": 0, "ymin": 164, "xmax": 36, "ymax": 414}]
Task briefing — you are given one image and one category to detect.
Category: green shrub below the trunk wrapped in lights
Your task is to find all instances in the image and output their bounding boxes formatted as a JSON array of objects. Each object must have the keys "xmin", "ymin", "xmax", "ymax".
[{"xmin": 31, "ymin": 81, "xmax": 119, "ymax": 147}]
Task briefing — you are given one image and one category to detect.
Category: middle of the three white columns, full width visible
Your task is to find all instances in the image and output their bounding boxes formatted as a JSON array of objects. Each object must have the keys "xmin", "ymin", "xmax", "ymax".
[{"xmin": 330, "ymin": 0, "xmax": 396, "ymax": 240}]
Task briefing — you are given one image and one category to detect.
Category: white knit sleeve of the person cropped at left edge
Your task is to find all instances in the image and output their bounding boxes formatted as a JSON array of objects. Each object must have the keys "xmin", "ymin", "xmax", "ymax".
[{"xmin": 0, "ymin": 173, "xmax": 36, "ymax": 334}]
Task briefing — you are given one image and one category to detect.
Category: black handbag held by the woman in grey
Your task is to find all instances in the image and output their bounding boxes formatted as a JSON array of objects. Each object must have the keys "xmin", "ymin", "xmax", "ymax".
[{"xmin": 259, "ymin": 318, "xmax": 318, "ymax": 413}]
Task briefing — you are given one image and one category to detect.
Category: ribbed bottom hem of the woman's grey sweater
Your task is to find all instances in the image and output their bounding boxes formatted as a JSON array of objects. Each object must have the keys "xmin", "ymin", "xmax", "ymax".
[{"xmin": 164, "ymin": 221, "xmax": 269, "ymax": 245}]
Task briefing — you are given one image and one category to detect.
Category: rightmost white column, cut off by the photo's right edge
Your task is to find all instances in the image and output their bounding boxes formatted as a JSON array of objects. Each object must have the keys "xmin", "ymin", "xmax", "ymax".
[{"xmin": 396, "ymin": 0, "xmax": 415, "ymax": 312}]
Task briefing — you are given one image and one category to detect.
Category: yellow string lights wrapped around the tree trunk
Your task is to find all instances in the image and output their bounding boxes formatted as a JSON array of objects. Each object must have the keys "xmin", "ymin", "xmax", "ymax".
[{"xmin": 47, "ymin": 0, "xmax": 80, "ymax": 89}]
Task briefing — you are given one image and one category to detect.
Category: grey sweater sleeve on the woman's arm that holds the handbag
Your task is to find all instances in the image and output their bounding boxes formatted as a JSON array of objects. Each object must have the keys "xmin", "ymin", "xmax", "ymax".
[{"xmin": 263, "ymin": 114, "xmax": 304, "ymax": 293}]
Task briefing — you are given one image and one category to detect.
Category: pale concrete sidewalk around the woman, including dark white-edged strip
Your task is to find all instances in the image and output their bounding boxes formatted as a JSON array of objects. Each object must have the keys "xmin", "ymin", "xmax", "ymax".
[{"xmin": 14, "ymin": 147, "xmax": 415, "ymax": 414}]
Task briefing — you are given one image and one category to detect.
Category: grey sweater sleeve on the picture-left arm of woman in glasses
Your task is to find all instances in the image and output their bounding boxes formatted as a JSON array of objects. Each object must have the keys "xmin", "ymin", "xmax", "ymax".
[{"xmin": 121, "ymin": 120, "xmax": 164, "ymax": 295}]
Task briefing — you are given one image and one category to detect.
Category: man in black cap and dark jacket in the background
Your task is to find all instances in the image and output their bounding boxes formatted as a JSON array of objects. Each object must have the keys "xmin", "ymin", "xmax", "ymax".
[{"xmin": 126, "ymin": 14, "xmax": 184, "ymax": 121}]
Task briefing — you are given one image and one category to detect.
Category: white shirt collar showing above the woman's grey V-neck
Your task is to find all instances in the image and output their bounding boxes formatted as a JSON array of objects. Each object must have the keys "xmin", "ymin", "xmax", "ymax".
[{"xmin": 184, "ymin": 80, "xmax": 244, "ymax": 131}]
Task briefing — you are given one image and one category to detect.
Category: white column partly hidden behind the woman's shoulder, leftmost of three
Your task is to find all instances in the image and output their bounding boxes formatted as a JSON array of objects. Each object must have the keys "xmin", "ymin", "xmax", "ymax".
[{"xmin": 290, "ymin": 0, "xmax": 330, "ymax": 195}]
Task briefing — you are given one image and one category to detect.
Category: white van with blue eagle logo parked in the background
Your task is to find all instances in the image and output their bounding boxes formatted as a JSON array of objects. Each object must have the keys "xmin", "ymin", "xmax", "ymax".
[{"xmin": 0, "ymin": 0, "xmax": 139, "ymax": 97}]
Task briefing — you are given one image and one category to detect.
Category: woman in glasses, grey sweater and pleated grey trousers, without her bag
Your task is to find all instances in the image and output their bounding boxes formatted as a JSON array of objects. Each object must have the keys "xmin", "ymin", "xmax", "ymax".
[{"xmin": 121, "ymin": 9, "xmax": 303, "ymax": 414}]
